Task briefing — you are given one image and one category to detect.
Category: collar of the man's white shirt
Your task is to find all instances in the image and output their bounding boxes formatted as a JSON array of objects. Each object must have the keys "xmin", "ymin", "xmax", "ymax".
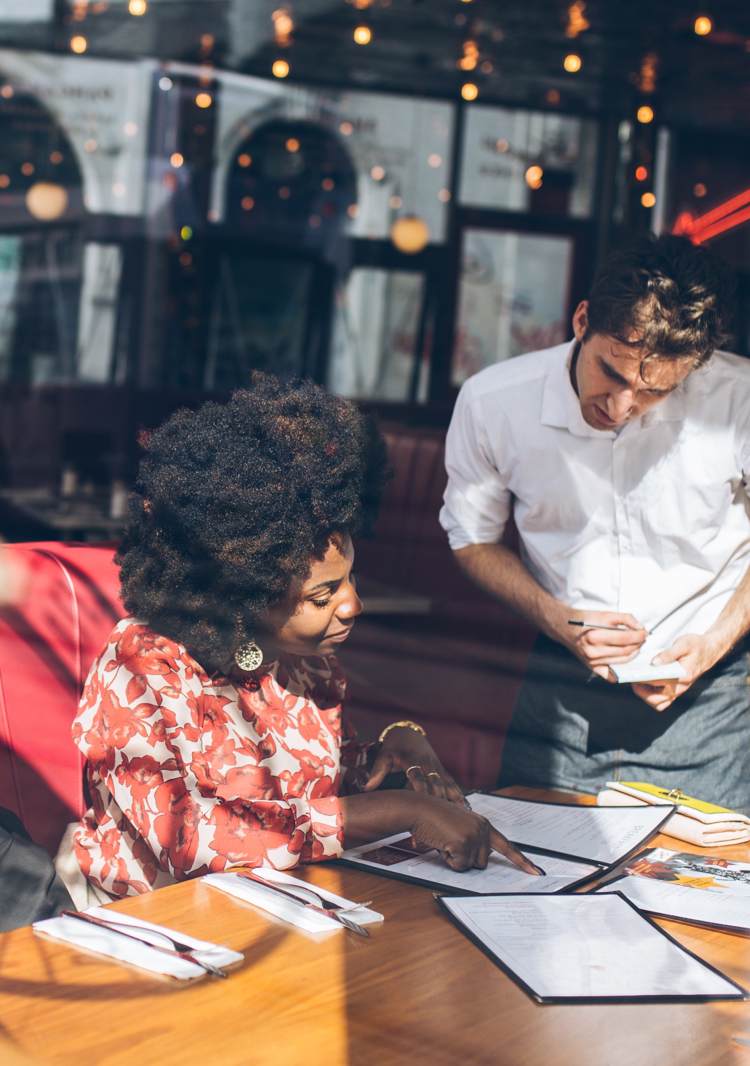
[{"xmin": 541, "ymin": 340, "xmax": 695, "ymax": 430}]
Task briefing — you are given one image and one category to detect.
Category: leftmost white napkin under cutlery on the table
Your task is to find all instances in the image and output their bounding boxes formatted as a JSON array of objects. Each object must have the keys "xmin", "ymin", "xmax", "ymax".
[{"xmin": 33, "ymin": 907, "xmax": 245, "ymax": 981}]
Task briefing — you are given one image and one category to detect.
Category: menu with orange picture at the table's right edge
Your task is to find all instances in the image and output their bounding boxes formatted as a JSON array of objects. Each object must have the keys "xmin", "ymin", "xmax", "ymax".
[{"xmin": 599, "ymin": 847, "xmax": 750, "ymax": 935}]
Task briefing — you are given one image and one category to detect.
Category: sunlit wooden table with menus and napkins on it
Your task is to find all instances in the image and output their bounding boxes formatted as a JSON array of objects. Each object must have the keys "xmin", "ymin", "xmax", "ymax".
[{"xmin": 0, "ymin": 789, "xmax": 750, "ymax": 1066}]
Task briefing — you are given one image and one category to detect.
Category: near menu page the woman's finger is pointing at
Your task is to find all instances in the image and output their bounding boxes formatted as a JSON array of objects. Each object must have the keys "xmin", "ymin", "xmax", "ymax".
[{"xmin": 342, "ymin": 833, "xmax": 601, "ymax": 892}]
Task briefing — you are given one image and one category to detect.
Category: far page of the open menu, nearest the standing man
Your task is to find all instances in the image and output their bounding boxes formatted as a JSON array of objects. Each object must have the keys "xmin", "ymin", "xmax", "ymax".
[{"xmin": 467, "ymin": 792, "xmax": 673, "ymax": 870}]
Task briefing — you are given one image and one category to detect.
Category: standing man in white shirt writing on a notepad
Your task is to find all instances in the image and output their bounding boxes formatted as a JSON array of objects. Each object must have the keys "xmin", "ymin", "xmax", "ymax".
[{"xmin": 440, "ymin": 237, "xmax": 750, "ymax": 809}]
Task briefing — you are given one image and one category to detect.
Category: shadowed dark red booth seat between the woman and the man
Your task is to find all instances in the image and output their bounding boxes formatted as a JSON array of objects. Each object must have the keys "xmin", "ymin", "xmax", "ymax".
[{"xmin": 349, "ymin": 425, "xmax": 536, "ymax": 788}]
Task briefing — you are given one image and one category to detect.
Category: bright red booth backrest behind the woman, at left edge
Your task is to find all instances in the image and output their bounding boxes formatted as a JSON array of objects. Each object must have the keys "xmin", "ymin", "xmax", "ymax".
[{"xmin": 0, "ymin": 543, "xmax": 124, "ymax": 852}]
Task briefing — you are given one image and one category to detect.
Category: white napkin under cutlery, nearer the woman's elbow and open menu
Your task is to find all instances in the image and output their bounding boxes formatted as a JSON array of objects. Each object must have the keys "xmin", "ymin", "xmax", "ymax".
[{"xmin": 200, "ymin": 867, "xmax": 382, "ymax": 933}]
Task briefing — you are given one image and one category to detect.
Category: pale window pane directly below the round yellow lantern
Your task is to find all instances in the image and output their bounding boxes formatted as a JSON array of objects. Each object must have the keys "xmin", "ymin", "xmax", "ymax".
[{"xmin": 328, "ymin": 269, "xmax": 428, "ymax": 403}]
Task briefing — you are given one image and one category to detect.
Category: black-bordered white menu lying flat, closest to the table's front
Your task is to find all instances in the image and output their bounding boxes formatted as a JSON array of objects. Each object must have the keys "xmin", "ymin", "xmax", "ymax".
[{"xmin": 442, "ymin": 894, "xmax": 745, "ymax": 1001}]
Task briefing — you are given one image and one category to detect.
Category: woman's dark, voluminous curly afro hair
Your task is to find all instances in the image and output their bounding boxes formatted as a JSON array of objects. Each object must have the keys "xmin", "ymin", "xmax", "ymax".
[{"xmin": 117, "ymin": 373, "xmax": 387, "ymax": 673}]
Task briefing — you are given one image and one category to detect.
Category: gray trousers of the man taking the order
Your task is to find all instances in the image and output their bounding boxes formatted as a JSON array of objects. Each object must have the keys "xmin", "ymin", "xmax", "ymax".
[{"xmin": 498, "ymin": 636, "xmax": 750, "ymax": 813}]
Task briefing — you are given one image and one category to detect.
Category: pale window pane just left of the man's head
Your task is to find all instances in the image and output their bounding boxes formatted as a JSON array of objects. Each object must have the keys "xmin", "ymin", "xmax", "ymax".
[{"xmin": 452, "ymin": 229, "xmax": 573, "ymax": 385}]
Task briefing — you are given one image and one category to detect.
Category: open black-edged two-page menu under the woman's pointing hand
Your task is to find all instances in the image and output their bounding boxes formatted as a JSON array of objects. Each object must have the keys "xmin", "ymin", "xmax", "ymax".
[{"xmin": 342, "ymin": 792, "xmax": 673, "ymax": 894}]
